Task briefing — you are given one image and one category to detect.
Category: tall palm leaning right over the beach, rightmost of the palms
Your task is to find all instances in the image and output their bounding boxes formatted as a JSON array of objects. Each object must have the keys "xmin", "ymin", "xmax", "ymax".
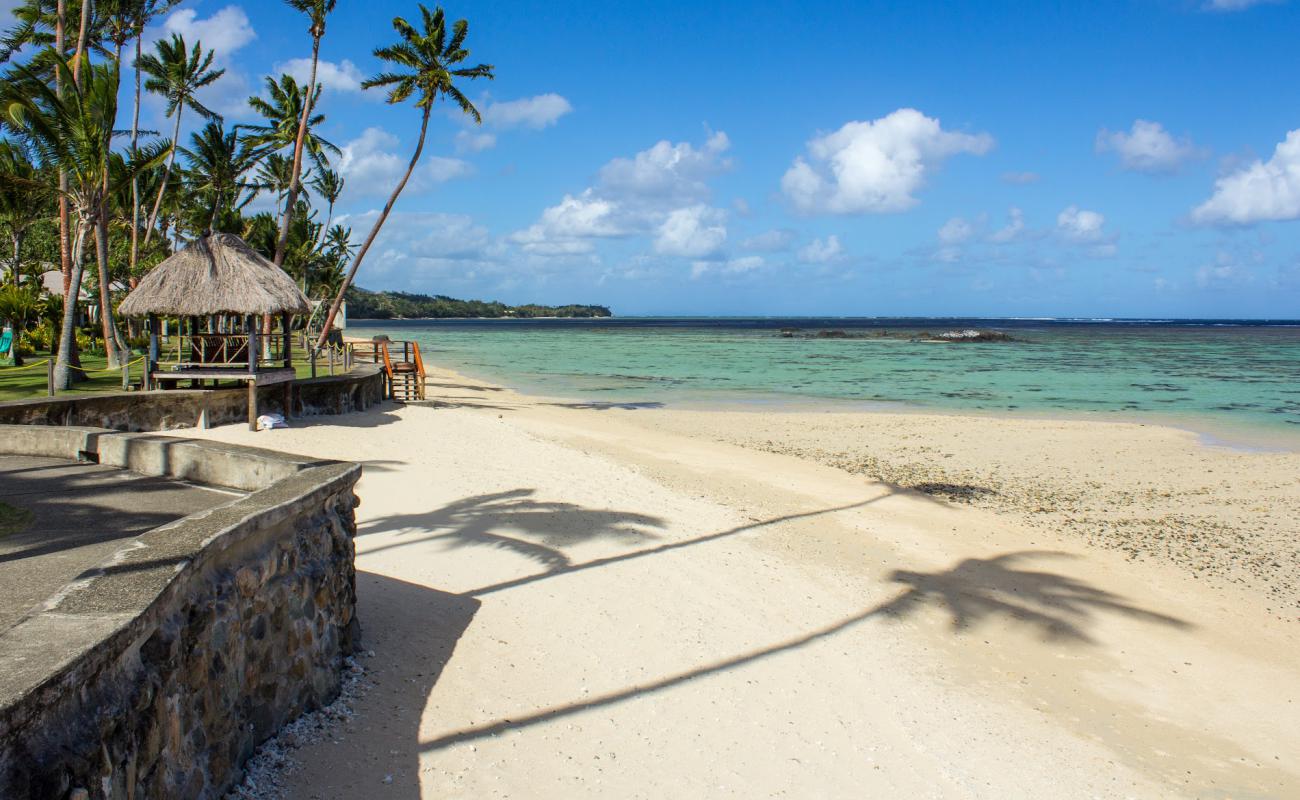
[{"xmin": 316, "ymin": 3, "xmax": 494, "ymax": 347}]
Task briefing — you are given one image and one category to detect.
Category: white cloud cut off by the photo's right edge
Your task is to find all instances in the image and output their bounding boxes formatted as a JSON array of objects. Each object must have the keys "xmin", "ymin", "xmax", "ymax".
[{"xmin": 1192, "ymin": 129, "xmax": 1300, "ymax": 225}]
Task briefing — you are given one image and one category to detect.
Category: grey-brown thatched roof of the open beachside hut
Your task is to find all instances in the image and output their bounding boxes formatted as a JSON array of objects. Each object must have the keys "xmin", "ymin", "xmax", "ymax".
[{"xmin": 121, "ymin": 233, "xmax": 311, "ymax": 316}]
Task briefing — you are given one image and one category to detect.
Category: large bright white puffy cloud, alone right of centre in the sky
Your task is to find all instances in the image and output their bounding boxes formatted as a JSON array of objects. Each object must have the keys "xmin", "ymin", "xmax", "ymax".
[{"xmin": 781, "ymin": 108, "xmax": 993, "ymax": 213}]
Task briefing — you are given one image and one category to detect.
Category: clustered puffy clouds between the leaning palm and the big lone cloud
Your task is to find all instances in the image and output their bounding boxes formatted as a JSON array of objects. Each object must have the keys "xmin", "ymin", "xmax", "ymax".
[{"xmin": 510, "ymin": 133, "xmax": 729, "ymax": 258}]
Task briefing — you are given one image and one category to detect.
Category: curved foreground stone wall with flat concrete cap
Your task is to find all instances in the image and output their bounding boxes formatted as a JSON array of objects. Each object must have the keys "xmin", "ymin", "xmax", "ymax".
[{"xmin": 0, "ymin": 427, "xmax": 360, "ymax": 800}]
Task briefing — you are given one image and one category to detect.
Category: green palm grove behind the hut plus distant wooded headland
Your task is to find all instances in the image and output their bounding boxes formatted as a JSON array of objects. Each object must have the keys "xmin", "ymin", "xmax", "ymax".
[{"xmin": 0, "ymin": 0, "xmax": 504, "ymax": 388}]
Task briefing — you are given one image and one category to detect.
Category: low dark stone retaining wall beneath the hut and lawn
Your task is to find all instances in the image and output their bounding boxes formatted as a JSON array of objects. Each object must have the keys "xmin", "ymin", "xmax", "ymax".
[{"xmin": 0, "ymin": 364, "xmax": 385, "ymax": 431}]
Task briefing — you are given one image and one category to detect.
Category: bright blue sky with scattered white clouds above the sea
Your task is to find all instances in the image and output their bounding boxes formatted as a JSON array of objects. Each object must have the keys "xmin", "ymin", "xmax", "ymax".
[{"xmin": 7, "ymin": 0, "xmax": 1300, "ymax": 317}]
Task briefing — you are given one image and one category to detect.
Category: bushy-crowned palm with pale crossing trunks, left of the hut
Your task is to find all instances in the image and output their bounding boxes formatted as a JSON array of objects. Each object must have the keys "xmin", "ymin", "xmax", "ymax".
[{"xmin": 4, "ymin": 56, "xmax": 170, "ymax": 389}]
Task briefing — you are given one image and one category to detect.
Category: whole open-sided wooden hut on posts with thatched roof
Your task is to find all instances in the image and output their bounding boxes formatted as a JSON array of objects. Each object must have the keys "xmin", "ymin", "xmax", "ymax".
[{"xmin": 121, "ymin": 233, "xmax": 311, "ymax": 431}]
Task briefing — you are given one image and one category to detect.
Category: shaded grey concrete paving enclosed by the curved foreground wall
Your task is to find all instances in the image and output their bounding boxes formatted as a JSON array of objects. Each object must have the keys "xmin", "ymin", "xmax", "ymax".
[{"xmin": 0, "ymin": 455, "xmax": 234, "ymax": 632}]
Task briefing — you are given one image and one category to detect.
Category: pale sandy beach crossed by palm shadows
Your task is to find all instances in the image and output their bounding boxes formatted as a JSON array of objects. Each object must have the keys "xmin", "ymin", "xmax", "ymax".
[{"xmin": 195, "ymin": 372, "xmax": 1300, "ymax": 799}]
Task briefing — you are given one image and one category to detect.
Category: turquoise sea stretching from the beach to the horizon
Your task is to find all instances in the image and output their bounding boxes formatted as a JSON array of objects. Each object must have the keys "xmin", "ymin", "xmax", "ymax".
[{"xmin": 348, "ymin": 319, "xmax": 1300, "ymax": 436}]
